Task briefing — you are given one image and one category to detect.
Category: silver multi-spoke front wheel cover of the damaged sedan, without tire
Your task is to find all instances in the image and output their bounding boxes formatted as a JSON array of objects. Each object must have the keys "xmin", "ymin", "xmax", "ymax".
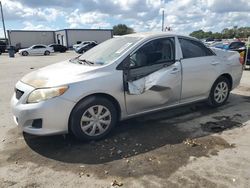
[{"xmin": 80, "ymin": 105, "xmax": 111, "ymax": 136}]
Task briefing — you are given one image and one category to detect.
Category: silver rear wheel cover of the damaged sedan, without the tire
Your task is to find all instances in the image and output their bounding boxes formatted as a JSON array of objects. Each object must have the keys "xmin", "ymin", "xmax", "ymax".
[{"xmin": 214, "ymin": 82, "xmax": 228, "ymax": 103}]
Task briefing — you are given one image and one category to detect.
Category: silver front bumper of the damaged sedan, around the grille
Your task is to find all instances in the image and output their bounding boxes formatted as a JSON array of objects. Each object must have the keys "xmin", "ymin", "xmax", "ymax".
[{"xmin": 11, "ymin": 81, "xmax": 75, "ymax": 135}]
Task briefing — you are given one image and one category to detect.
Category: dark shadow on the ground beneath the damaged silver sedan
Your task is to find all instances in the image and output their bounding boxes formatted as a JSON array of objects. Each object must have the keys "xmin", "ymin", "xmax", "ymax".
[{"xmin": 23, "ymin": 94, "xmax": 246, "ymax": 164}]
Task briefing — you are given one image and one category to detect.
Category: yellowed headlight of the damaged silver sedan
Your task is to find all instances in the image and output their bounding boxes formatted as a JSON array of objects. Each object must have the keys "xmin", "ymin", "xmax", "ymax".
[{"xmin": 27, "ymin": 86, "xmax": 68, "ymax": 103}]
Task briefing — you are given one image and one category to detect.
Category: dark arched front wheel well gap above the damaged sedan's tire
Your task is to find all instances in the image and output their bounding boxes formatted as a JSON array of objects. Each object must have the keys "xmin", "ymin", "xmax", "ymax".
[{"xmin": 68, "ymin": 93, "xmax": 121, "ymax": 132}]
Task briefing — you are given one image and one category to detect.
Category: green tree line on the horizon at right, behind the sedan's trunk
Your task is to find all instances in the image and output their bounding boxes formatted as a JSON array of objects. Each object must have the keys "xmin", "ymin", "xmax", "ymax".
[{"xmin": 190, "ymin": 26, "xmax": 250, "ymax": 39}]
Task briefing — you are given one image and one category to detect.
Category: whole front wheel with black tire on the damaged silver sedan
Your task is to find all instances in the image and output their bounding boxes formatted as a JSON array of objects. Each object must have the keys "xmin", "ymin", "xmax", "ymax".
[{"xmin": 69, "ymin": 96, "xmax": 117, "ymax": 140}]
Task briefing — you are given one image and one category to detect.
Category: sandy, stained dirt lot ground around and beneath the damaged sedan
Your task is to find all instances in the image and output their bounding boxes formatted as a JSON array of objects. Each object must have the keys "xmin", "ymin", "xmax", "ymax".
[{"xmin": 0, "ymin": 52, "xmax": 250, "ymax": 188}]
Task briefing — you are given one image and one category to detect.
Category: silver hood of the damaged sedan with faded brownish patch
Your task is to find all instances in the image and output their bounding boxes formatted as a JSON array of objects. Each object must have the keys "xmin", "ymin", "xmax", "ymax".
[{"xmin": 21, "ymin": 61, "xmax": 100, "ymax": 88}]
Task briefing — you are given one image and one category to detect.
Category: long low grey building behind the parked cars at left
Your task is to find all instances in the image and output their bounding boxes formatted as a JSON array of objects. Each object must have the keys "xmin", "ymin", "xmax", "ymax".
[{"xmin": 7, "ymin": 29, "xmax": 113, "ymax": 49}]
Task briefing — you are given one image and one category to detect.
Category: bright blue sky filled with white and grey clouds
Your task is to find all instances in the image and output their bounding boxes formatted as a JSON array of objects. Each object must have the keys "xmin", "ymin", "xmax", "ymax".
[{"xmin": 0, "ymin": 0, "xmax": 250, "ymax": 37}]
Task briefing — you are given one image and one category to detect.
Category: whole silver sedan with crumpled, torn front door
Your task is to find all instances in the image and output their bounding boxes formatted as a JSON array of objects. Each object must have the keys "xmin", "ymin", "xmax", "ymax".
[{"xmin": 11, "ymin": 32, "xmax": 242, "ymax": 140}]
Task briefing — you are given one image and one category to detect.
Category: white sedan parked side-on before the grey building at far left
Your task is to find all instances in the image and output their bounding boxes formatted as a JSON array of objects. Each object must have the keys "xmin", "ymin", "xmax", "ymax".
[{"xmin": 18, "ymin": 44, "xmax": 54, "ymax": 56}]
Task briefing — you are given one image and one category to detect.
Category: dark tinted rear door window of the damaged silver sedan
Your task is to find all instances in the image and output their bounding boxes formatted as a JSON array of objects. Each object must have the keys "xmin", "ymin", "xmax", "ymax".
[{"xmin": 179, "ymin": 38, "xmax": 214, "ymax": 59}]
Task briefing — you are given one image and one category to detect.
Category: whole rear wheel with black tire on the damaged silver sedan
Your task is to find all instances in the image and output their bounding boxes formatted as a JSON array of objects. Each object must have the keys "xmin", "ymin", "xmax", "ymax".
[{"xmin": 208, "ymin": 76, "xmax": 231, "ymax": 107}]
